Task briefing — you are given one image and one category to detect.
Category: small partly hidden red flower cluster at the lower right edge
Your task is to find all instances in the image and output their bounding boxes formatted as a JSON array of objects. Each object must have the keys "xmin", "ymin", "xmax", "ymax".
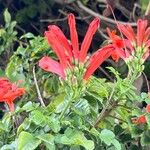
[{"xmin": 131, "ymin": 104, "xmax": 150, "ymax": 124}]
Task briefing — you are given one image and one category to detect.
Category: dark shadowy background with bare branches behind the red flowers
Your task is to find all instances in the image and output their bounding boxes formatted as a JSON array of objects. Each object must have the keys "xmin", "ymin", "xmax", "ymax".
[{"xmin": 0, "ymin": 0, "xmax": 150, "ymax": 88}]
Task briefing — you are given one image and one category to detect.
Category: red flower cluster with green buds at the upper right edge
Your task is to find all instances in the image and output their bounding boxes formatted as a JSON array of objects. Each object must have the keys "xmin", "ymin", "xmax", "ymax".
[{"xmin": 107, "ymin": 19, "xmax": 150, "ymax": 63}]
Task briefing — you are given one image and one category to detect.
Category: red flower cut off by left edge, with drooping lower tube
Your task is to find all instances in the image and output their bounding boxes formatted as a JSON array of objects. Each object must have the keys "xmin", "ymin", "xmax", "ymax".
[{"xmin": 0, "ymin": 78, "xmax": 25, "ymax": 112}]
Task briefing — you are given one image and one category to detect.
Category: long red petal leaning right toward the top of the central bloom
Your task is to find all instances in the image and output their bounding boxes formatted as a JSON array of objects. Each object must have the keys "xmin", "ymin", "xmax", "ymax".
[{"xmin": 80, "ymin": 18, "xmax": 100, "ymax": 62}]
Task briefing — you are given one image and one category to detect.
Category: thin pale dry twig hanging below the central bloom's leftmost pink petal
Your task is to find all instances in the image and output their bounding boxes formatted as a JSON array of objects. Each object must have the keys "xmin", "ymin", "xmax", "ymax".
[{"xmin": 33, "ymin": 66, "xmax": 45, "ymax": 107}]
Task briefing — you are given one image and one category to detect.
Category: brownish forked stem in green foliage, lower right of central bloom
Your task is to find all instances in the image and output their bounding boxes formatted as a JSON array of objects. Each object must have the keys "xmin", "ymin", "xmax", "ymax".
[{"xmin": 93, "ymin": 88, "xmax": 116, "ymax": 127}]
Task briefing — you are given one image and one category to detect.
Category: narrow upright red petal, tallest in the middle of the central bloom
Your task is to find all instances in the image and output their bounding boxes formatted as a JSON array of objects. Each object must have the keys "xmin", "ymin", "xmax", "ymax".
[{"xmin": 68, "ymin": 14, "xmax": 79, "ymax": 58}]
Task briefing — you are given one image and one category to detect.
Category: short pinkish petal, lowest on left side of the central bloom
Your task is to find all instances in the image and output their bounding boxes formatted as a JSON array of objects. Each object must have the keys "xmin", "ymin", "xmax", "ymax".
[{"xmin": 39, "ymin": 56, "xmax": 65, "ymax": 79}]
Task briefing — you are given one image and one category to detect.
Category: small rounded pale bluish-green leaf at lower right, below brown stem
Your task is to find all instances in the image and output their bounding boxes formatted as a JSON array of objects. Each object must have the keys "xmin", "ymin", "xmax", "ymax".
[{"xmin": 100, "ymin": 129, "xmax": 115, "ymax": 146}]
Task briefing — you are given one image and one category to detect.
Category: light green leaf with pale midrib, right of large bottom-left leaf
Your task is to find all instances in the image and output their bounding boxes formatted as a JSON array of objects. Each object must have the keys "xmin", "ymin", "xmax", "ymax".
[{"xmin": 37, "ymin": 134, "xmax": 55, "ymax": 150}]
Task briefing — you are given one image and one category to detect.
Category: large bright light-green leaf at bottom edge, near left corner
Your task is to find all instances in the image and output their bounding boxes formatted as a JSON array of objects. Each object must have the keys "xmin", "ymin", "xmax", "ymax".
[{"xmin": 18, "ymin": 131, "xmax": 41, "ymax": 150}]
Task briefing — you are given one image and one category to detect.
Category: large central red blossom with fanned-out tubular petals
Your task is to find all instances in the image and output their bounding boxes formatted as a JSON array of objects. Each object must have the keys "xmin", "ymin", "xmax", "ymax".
[{"xmin": 39, "ymin": 14, "xmax": 114, "ymax": 80}]
